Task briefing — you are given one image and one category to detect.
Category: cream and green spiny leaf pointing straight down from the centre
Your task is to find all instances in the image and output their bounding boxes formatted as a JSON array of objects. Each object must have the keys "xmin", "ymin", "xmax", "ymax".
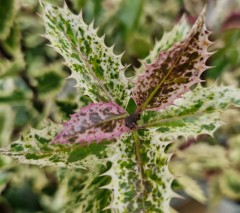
[{"xmin": 103, "ymin": 130, "xmax": 173, "ymax": 212}]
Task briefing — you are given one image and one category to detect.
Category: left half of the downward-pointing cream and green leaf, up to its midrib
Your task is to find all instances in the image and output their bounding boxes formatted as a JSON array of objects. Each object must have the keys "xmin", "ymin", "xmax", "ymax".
[{"xmin": 103, "ymin": 133, "xmax": 143, "ymax": 212}]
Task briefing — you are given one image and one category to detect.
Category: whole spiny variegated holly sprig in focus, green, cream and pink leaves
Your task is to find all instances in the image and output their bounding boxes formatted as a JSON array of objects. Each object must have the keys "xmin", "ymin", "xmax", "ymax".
[{"xmin": 1, "ymin": 2, "xmax": 240, "ymax": 213}]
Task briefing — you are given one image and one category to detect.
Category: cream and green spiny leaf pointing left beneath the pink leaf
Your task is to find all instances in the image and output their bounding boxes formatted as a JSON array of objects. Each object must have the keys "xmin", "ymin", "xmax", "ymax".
[{"xmin": 0, "ymin": 123, "xmax": 107, "ymax": 170}]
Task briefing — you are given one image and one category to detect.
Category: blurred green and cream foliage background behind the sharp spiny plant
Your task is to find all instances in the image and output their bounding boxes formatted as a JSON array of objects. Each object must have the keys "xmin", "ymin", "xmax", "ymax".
[{"xmin": 0, "ymin": 0, "xmax": 240, "ymax": 213}]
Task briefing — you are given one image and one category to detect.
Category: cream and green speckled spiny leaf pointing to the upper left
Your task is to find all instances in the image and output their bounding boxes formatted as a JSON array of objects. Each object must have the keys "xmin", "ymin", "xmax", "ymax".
[{"xmin": 41, "ymin": 2, "xmax": 129, "ymax": 107}]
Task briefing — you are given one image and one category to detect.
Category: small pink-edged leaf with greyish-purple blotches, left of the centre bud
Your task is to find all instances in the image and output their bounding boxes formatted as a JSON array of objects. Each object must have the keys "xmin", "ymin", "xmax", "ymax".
[{"xmin": 53, "ymin": 102, "xmax": 130, "ymax": 144}]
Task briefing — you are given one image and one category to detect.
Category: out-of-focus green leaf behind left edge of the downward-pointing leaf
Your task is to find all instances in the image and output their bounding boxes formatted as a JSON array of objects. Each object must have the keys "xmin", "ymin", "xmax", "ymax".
[{"xmin": 64, "ymin": 166, "xmax": 111, "ymax": 213}]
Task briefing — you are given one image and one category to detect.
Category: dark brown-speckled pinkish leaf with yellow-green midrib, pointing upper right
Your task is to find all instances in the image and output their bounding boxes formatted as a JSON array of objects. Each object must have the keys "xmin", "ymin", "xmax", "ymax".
[{"xmin": 132, "ymin": 7, "xmax": 212, "ymax": 111}]
